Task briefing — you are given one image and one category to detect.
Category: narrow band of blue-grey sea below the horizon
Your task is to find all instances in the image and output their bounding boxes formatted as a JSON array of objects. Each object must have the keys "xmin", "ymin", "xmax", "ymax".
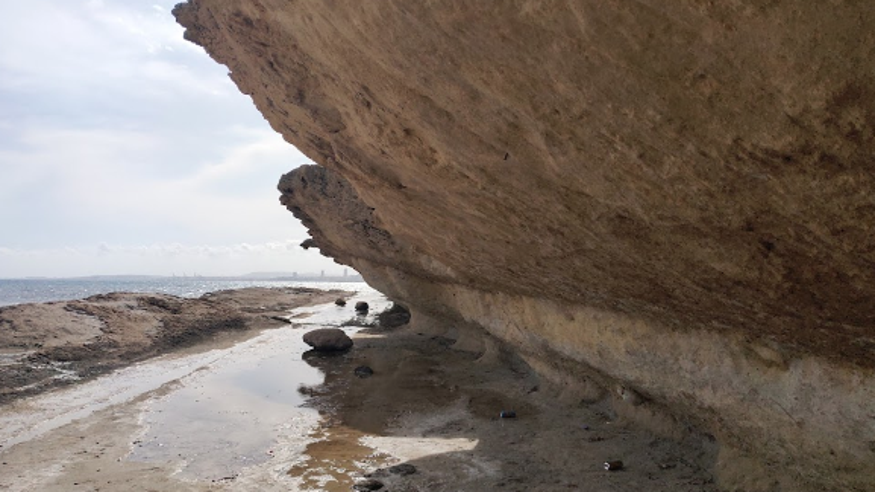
[{"xmin": 0, "ymin": 277, "xmax": 365, "ymax": 306}]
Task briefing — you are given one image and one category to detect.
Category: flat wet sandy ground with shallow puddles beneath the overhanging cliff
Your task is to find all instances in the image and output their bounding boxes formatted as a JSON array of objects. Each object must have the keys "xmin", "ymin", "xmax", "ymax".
[{"xmin": 0, "ymin": 290, "xmax": 716, "ymax": 492}]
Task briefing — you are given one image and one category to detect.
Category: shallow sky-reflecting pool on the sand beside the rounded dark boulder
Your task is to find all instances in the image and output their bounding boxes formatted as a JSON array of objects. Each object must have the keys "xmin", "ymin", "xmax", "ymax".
[{"xmin": 129, "ymin": 284, "xmax": 389, "ymax": 480}]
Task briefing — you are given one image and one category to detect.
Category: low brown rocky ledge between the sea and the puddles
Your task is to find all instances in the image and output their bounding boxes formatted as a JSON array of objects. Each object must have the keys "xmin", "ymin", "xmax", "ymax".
[{"xmin": 0, "ymin": 287, "xmax": 352, "ymax": 408}]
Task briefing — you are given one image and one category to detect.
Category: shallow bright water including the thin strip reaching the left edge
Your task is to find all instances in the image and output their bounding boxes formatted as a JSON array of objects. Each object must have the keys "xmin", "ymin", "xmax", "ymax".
[{"xmin": 0, "ymin": 284, "xmax": 390, "ymax": 480}]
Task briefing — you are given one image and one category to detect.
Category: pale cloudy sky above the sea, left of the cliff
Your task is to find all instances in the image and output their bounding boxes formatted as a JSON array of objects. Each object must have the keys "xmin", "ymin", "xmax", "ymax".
[{"xmin": 0, "ymin": 0, "xmax": 343, "ymax": 278}]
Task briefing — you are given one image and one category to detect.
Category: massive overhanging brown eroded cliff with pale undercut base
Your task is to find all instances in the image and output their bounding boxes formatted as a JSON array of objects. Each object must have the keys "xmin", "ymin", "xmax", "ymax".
[{"xmin": 175, "ymin": 0, "xmax": 875, "ymax": 490}]
